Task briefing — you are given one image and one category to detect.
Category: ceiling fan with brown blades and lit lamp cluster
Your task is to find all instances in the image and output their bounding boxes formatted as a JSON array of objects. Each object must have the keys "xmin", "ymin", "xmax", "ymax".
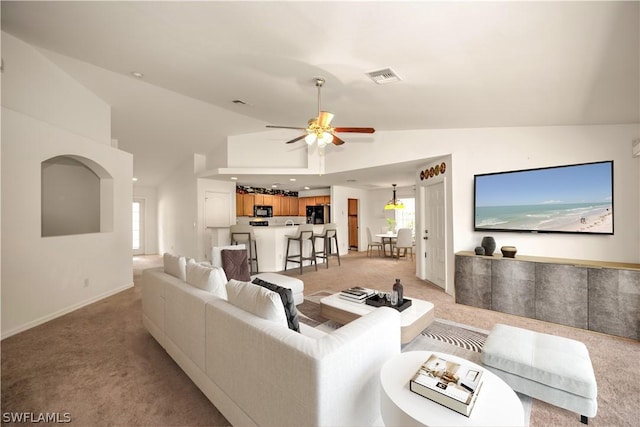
[{"xmin": 267, "ymin": 77, "xmax": 376, "ymax": 147}]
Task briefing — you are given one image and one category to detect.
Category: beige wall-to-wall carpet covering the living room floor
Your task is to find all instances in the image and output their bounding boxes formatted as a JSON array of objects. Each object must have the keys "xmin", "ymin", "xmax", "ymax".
[{"xmin": 1, "ymin": 252, "xmax": 640, "ymax": 427}]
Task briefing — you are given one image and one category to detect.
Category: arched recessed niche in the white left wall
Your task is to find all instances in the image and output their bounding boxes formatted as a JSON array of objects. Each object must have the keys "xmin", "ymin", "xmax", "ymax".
[{"xmin": 40, "ymin": 155, "xmax": 113, "ymax": 237}]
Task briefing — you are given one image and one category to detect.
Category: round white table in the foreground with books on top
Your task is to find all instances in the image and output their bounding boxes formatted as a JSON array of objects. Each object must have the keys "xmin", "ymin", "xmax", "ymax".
[{"xmin": 380, "ymin": 351, "xmax": 524, "ymax": 427}]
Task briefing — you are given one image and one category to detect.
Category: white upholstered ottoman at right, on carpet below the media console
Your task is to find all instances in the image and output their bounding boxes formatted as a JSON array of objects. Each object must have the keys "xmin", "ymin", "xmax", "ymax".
[{"xmin": 482, "ymin": 324, "xmax": 598, "ymax": 424}]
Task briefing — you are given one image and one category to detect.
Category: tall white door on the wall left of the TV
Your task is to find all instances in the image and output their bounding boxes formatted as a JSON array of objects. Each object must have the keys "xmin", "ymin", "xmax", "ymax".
[{"xmin": 424, "ymin": 182, "xmax": 447, "ymax": 289}]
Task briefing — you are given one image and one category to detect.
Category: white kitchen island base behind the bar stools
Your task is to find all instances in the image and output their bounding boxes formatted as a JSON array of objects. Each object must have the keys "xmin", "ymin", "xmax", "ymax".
[{"xmin": 253, "ymin": 224, "xmax": 324, "ymax": 272}]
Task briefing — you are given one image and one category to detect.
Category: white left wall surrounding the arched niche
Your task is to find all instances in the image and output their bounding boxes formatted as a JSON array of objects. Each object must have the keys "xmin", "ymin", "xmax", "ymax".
[{"xmin": 1, "ymin": 33, "xmax": 133, "ymax": 338}]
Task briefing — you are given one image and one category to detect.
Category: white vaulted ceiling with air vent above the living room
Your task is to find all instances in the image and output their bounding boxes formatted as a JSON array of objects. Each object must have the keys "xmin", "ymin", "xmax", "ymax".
[{"xmin": 1, "ymin": 0, "xmax": 640, "ymax": 189}]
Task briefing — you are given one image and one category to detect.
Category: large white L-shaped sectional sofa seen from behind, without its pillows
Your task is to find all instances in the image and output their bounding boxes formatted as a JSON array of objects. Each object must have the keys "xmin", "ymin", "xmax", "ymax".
[{"xmin": 142, "ymin": 256, "xmax": 400, "ymax": 426}]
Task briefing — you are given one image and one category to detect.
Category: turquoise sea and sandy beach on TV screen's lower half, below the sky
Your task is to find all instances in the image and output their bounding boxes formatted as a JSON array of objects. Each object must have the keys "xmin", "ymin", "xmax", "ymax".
[{"xmin": 475, "ymin": 202, "xmax": 613, "ymax": 233}]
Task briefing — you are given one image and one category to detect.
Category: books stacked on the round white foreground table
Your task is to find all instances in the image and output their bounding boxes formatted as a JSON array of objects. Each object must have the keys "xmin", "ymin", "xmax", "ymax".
[{"xmin": 409, "ymin": 354, "xmax": 482, "ymax": 417}]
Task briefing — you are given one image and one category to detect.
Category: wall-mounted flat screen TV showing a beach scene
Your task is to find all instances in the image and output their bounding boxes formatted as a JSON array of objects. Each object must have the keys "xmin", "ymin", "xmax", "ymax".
[{"xmin": 474, "ymin": 161, "xmax": 613, "ymax": 234}]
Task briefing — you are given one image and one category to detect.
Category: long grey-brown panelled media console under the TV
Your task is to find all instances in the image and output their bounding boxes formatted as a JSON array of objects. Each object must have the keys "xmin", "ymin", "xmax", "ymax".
[{"xmin": 455, "ymin": 252, "xmax": 640, "ymax": 340}]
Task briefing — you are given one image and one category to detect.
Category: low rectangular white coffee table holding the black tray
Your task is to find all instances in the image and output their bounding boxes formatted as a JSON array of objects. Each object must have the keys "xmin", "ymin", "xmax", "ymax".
[{"xmin": 320, "ymin": 293, "xmax": 435, "ymax": 344}]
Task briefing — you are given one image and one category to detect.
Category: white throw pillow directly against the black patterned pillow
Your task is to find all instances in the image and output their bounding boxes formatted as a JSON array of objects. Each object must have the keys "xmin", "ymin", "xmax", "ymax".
[{"xmin": 227, "ymin": 279, "xmax": 289, "ymax": 328}]
